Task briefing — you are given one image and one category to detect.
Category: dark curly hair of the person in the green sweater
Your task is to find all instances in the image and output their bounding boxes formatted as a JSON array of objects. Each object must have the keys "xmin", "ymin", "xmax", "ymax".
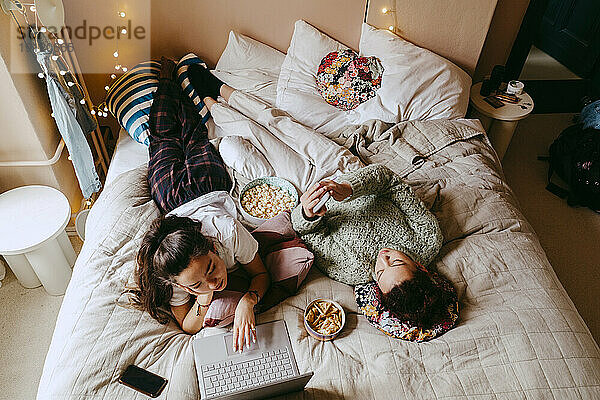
[{"xmin": 379, "ymin": 268, "xmax": 448, "ymax": 329}]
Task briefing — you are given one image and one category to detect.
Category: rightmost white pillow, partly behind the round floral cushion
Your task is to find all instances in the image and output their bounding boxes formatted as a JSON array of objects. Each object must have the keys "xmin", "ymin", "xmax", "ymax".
[{"xmin": 351, "ymin": 23, "xmax": 471, "ymax": 123}]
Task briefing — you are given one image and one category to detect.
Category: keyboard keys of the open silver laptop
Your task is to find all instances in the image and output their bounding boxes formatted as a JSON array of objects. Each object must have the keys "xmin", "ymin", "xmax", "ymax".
[{"xmin": 202, "ymin": 347, "xmax": 294, "ymax": 396}]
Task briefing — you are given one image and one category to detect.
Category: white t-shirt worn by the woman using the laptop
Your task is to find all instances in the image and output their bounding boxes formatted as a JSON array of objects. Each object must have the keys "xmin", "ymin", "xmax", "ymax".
[{"xmin": 168, "ymin": 191, "xmax": 258, "ymax": 306}]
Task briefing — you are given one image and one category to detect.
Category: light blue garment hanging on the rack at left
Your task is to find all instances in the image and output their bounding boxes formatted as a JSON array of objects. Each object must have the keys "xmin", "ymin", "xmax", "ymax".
[{"xmin": 25, "ymin": 27, "xmax": 102, "ymax": 199}]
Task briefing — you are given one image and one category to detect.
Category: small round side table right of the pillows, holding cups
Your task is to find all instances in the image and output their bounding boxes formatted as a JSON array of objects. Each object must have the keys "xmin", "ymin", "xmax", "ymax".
[{"xmin": 470, "ymin": 82, "xmax": 534, "ymax": 161}]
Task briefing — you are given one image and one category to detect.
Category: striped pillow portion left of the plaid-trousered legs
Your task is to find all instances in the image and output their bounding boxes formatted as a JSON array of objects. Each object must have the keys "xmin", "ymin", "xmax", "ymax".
[{"xmin": 106, "ymin": 61, "xmax": 160, "ymax": 146}]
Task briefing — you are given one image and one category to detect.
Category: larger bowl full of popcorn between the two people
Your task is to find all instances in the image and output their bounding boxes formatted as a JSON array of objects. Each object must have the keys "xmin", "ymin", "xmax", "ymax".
[{"xmin": 239, "ymin": 176, "xmax": 299, "ymax": 226}]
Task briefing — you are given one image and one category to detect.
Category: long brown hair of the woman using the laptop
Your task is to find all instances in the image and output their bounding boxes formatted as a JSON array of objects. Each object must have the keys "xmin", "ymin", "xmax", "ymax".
[{"xmin": 126, "ymin": 216, "xmax": 214, "ymax": 324}]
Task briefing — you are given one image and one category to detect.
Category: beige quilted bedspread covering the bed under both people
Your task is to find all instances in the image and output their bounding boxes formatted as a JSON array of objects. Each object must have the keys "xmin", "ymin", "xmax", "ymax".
[{"xmin": 38, "ymin": 121, "xmax": 600, "ymax": 400}]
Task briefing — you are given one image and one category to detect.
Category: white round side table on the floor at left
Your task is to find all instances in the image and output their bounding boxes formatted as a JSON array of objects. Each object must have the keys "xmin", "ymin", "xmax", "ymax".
[{"xmin": 0, "ymin": 186, "xmax": 77, "ymax": 296}]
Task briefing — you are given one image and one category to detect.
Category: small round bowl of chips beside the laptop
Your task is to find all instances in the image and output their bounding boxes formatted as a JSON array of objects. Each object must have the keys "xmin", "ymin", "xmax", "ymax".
[{"xmin": 304, "ymin": 299, "xmax": 346, "ymax": 342}]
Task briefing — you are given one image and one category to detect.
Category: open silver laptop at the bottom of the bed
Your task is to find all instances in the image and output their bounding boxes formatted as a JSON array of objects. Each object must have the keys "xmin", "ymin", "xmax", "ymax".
[{"xmin": 192, "ymin": 320, "xmax": 313, "ymax": 400}]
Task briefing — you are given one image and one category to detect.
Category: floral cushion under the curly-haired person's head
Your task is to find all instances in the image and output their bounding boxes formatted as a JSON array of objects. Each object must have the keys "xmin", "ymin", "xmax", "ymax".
[{"xmin": 354, "ymin": 273, "xmax": 458, "ymax": 342}]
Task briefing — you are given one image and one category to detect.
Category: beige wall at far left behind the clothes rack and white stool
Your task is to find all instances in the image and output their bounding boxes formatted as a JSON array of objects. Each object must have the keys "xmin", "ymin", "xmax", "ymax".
[{"xmin": 0, "ymin": 13, "xmax": 82, "ymax": 211}]
